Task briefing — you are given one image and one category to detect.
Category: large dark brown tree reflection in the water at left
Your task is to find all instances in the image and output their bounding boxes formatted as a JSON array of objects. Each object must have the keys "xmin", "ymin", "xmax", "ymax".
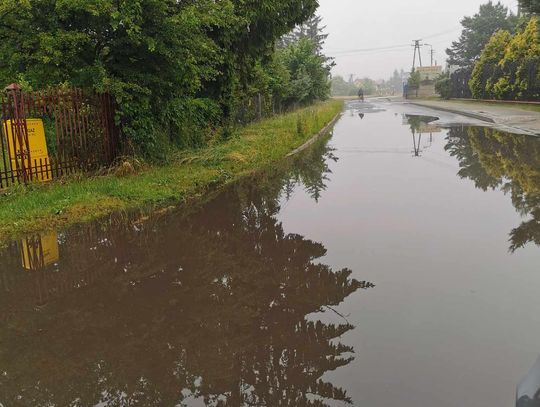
[{"xmin": 0, "ymin": 138, "xmax": 369, "ymax": 407}]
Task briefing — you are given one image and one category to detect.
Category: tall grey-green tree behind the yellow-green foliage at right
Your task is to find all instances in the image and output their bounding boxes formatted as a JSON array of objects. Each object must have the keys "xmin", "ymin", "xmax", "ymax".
[{"xmin": 446, "ymin": 1, "xmax": 517, "ymax": 68}]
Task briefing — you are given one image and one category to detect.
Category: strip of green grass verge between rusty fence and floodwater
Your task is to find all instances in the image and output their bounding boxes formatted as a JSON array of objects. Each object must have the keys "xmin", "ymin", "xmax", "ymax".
[{"xmin": 0, "ymin": 100, "xmax": 343, "ymax": 242}]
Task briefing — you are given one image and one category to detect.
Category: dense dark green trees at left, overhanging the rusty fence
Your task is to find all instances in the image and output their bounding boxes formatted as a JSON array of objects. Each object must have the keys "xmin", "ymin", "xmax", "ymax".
[{"xmin": 0, "ymin": 0, "xmax": 329, "ymax": 153}]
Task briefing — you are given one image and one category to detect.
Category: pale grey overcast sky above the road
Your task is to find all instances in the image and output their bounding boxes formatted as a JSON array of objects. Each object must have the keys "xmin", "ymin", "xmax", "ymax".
[{"xmin": 319, "ymin": 0, "xmax": 517, "ymax": 79}]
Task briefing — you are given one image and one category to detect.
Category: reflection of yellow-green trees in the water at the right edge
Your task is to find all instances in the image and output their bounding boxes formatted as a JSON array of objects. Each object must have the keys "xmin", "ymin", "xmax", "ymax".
[{"xmin": 446, "ymin": 127, "xmax": 540, "ymax": 251}]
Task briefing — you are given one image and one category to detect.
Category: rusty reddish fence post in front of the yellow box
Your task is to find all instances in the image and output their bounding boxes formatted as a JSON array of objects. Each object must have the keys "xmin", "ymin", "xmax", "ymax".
[{"xmin": 5, "ymin": 83, "xmax": 32, "ymax": 183}]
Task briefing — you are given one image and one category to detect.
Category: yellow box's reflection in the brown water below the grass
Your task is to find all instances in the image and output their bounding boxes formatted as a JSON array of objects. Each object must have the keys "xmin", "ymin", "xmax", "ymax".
[{"xmin": 22, "ymin": 231, "xmax": 60, "ymax": 270}]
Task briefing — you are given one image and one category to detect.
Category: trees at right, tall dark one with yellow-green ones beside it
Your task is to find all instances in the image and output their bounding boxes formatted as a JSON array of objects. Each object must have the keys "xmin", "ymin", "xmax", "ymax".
[{"xmin": 438, "ymin": 0, "xmax": 540, "ymax": 100}]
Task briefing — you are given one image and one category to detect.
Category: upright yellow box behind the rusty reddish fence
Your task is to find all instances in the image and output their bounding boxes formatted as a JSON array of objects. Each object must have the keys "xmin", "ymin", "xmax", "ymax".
[{"xmin": 4, "ymin": 119, "xmax": 52, "ymax": 181}]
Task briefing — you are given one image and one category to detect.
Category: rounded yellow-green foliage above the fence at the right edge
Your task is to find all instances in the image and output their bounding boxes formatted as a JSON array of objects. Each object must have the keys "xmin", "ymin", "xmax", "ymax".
[{"xmin": 469, "ymin": 17, "xmax": 540, "ymax": 100}]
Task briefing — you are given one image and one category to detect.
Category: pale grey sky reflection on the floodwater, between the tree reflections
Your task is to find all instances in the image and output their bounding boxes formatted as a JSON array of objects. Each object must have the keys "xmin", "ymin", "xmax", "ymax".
[{"xmin": 279, "ymin": 103, "xmax": 540, "ymax": 407}]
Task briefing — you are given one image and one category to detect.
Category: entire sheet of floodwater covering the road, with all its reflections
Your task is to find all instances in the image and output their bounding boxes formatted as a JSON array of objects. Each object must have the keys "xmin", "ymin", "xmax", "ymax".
[{"xmin": 0, "ymin": 99, "xmax": 540, "ymax": 407}]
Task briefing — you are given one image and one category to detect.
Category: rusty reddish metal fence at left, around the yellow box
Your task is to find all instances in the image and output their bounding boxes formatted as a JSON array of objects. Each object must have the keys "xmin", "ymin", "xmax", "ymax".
[{"xmin": 0, "ymin": 84, "xmax": 120, "ymax": 188}]
